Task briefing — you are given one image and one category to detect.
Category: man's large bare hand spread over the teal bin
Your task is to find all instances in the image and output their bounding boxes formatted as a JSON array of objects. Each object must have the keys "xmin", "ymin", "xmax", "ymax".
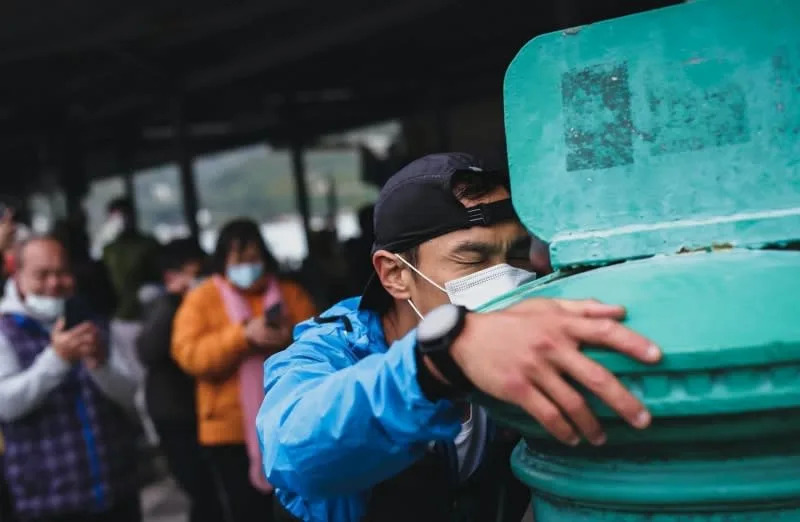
[{"xmin": 451, "ymin": 299, "xmax": 661, "ymax": 445}]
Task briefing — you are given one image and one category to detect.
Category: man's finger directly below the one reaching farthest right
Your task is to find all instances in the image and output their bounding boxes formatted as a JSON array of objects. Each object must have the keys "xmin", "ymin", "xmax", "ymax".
[{"xmin": 556, "ymin": 350, "xmax": 651, "ymax": 429}]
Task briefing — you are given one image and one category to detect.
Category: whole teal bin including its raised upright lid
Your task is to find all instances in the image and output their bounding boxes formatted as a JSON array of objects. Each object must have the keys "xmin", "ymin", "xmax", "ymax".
[{"xmin": 490, "ymin": 0, "xmax": 800, "ymax": 512}]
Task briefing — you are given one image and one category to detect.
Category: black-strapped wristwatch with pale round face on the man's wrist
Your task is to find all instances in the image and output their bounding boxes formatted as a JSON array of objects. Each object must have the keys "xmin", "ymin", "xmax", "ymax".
[{"xmin": 417, "ymin": 304, "xmax": 474, "ymax": 393}]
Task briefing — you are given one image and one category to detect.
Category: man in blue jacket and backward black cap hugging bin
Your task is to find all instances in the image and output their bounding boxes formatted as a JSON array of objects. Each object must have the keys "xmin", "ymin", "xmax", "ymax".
[{"xmin": 257, "ymin": 154, "xmax": 659, "ymax": 522}]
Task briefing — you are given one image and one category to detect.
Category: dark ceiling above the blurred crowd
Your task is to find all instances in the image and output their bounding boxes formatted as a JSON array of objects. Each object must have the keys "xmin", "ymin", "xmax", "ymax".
[{"xmin": 0, "ymin": 0, "xmax": 678, "ymax": 193}]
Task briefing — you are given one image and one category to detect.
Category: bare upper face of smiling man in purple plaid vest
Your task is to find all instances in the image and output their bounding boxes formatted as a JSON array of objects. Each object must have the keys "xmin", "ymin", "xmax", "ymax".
[{"xmin": 15, "ymin": 239, "xmax": 75, "ymax": 297}]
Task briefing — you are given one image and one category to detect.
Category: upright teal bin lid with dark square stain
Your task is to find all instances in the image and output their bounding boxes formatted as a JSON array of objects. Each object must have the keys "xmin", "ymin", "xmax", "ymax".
[{"xmin": 504, "ymin": 0, "xmax": 800, "ymax": 268}]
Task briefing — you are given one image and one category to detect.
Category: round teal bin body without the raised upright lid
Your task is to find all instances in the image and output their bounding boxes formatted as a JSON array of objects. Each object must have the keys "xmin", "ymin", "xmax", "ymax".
[{"xmin": 481, "ymin": 251, "xmax": 800, "ymax": 522}]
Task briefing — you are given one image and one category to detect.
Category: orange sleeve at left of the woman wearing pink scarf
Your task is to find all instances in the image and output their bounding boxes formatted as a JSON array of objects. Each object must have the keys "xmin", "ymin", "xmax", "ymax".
[{"xmin": 172, "ymin": 286, "xmax": 248, "ymax": 379}]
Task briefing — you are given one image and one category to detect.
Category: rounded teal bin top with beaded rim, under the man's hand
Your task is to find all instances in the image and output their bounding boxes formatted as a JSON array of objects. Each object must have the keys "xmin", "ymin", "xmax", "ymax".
[{"xmin": 472, "ymin": 250, "xmax": 800, "ymax": 438}]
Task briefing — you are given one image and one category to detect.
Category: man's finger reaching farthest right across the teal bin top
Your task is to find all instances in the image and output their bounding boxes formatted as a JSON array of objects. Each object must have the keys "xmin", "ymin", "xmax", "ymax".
[{"xmin": 564, "ymin": 317, "xmax": 661, "ymax": 363}]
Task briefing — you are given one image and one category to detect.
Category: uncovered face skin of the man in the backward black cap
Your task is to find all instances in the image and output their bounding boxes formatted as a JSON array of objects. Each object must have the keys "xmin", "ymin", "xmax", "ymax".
[{"xmin": 406, "ymin": 188, "xmax": 531, "ymax": 314}]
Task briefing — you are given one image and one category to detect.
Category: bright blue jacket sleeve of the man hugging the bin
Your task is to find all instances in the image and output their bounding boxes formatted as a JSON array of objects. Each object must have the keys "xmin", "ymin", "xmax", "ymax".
[{"xmin": 256, "ymin": 328, "xmax": 460, "ymax": 498}]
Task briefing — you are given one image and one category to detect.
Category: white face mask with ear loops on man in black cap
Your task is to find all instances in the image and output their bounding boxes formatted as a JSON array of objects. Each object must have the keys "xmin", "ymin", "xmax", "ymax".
[{"xmin": 397, "ymin": 256, "xmax": 536, "ymax": 318}]
